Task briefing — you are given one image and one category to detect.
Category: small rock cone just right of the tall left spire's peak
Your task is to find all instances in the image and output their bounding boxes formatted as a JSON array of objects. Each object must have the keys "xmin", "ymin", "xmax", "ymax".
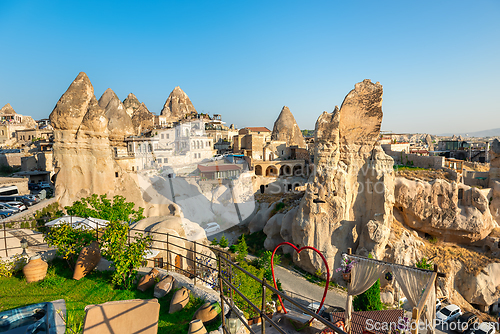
[{"xmin": 99, "ymin": 88, "xmax": 136, "ymax": 146}]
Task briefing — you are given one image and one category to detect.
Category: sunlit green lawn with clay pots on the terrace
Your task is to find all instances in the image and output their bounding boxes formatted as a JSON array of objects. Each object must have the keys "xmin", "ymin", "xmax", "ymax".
[{"xmin": 0, "ymin": 259, "xmax": 220, "ymax": 334}]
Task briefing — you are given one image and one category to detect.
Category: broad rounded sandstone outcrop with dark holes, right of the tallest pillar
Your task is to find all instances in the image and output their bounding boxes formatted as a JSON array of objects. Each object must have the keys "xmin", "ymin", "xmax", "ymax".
[{"xmin": 394, "ymin": 177, "xmax": 496, "ymax": 243}]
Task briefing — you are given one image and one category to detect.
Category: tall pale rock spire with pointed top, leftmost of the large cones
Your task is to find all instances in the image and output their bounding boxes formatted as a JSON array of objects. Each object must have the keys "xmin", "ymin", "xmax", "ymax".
[{"xmin": 50, "ymin": 72, "xmax": 145, "ymax": 207}]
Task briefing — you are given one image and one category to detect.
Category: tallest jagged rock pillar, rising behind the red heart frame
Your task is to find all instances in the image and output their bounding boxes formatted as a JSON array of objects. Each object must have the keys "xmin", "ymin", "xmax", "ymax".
[{"xmin": 266, "ymin": 80, "xmax": 394, "ymax": 275}]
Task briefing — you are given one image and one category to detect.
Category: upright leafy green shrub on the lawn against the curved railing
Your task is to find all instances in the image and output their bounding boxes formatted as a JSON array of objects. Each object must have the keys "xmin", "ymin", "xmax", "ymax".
[{"xmin": 102, "ymin": 221, "xmax": 151, "ymax": 289}]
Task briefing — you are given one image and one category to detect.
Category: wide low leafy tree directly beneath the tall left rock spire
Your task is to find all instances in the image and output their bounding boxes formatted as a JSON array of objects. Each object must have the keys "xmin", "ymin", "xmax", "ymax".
[{"xmin": 64, "ymin": 194, "xmax": 144, "ymax": 222}]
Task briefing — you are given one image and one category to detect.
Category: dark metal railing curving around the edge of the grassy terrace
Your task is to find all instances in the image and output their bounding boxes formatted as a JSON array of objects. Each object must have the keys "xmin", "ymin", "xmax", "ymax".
[{"xmin": 0, "ymin": 220, "xmax": 346, "ymax": 334}]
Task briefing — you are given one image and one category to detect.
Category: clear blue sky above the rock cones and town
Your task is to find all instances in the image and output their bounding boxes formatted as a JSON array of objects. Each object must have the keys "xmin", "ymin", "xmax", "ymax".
[{"xmin": 0, "ymin": 0, "xmax": 500, "ymax": 133}]
